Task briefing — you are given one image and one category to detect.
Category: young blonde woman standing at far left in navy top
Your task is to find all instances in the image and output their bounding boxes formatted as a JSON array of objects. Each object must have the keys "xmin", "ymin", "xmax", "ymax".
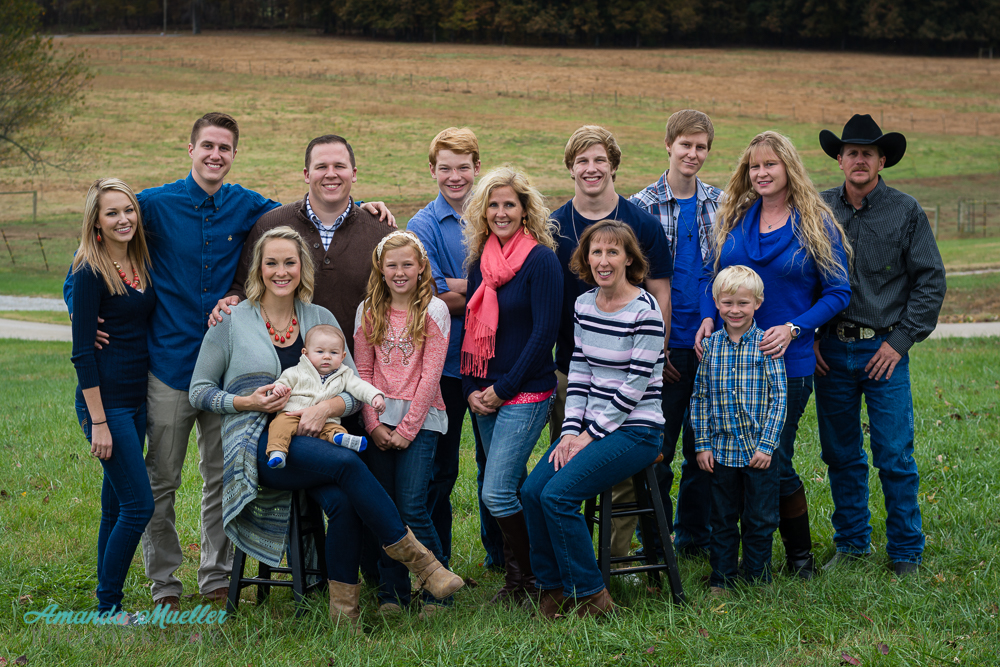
[{"xmin": 71, "ymin": 178, "xmax": 156, "ymax": 624}]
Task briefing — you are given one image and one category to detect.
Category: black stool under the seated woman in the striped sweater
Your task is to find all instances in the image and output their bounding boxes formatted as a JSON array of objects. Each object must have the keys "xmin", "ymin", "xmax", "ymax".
[{"xmin": 583, "ymin": 454, "xmax": 684, "ymax": 604}]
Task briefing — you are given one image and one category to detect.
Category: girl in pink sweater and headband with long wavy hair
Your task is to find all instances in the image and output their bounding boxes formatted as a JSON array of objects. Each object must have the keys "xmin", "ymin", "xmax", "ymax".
[{"xmin": 354, "ymin": 231, "xmax": 461, "ymax": 613}]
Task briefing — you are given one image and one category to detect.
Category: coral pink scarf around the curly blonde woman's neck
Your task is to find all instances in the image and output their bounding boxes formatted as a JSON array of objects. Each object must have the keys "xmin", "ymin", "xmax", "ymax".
[{"xmin": 462, "ymin": 230, "xmax": 538, "ymax": 377}]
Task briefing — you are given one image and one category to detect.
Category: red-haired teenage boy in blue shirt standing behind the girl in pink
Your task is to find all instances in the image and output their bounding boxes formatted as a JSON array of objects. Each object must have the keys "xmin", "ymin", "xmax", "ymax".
[{"xmin": 406, "ymin": 127, "xmax": 504, "ymax": 567}]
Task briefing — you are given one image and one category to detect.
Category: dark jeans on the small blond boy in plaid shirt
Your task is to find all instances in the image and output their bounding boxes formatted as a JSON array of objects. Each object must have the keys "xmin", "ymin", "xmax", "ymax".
[{"xmin": 709, "ymin": 457, "xmax": 779, "ymax": 588}]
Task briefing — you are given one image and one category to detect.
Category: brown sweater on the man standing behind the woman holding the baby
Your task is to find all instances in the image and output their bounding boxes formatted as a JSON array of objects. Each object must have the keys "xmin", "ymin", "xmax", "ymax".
[{"xmin": 226, "ymin": 198, "xmax": 395, "ymax": 355}]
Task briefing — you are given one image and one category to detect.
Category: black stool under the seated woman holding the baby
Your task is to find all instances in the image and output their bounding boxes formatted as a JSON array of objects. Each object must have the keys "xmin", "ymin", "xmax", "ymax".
[{"xmin": 226, "ymin": 491, "xmax": 327, "ymax": 616}]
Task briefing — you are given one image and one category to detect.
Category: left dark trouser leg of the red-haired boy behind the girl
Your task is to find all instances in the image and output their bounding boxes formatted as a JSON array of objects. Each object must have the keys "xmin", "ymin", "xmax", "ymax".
[{"xmin": 426, "ymin": 376, "xmax": 469, "ymax": 567}]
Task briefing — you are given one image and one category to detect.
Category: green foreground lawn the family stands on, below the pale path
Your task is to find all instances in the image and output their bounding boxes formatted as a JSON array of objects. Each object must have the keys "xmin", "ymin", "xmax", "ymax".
[{"xmin": 0, "ymin": 339, "xmax": 1000, "ymax": 667}]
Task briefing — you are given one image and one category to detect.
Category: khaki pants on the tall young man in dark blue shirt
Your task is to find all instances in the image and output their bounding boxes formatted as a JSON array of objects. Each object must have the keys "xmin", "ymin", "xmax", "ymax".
[{"xmin": 142, "ymin": 373, "xmax": 233, "ymax": 600}]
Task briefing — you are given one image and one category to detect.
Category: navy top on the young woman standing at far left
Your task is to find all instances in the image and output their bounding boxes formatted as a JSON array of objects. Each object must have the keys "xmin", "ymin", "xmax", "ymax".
[{"xmin": 73, "ymin": 265, "xmax": 155, "ymax": 408}]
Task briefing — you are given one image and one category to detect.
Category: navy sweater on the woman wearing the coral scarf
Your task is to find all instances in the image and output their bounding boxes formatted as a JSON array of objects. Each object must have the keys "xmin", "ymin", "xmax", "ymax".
[{"xmin": 462, "ymin": 244, "xmax": 563, "ymax": 401}]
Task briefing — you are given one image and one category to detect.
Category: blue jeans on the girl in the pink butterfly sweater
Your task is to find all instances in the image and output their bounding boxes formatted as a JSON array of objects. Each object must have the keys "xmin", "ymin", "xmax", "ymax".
[{"xmin": 368, "ymin": 430, "xmax": 444, "ymax": 606}]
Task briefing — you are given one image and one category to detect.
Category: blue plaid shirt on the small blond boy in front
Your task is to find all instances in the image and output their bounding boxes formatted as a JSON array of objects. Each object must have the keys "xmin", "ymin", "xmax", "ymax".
[{"xmin": 691, "ymin": 322, "xmax": 788, "ymax": 468}]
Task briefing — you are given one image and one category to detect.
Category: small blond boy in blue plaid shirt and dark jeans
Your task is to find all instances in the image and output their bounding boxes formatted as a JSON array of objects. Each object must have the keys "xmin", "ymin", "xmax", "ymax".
[{"xmin": 691, "ymin": 265, "xmax": 787, "ymax": 595}]
